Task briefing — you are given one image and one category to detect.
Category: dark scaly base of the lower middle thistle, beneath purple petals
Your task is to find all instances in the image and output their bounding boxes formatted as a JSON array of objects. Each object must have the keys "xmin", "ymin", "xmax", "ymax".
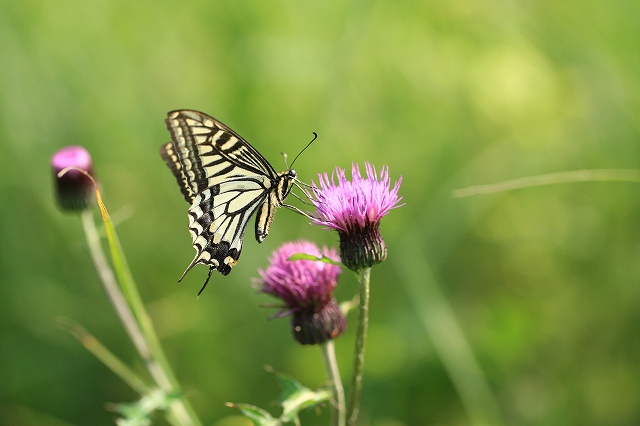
[{"xmin": 291, "ymin": 299, "xmax": 347, "ymax": 345}]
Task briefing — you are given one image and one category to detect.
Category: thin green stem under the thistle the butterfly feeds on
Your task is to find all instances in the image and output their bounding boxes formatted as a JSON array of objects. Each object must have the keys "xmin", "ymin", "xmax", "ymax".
[{"xmin": 347, "ymin": 268, "xmax": 371, "ymax": 425}]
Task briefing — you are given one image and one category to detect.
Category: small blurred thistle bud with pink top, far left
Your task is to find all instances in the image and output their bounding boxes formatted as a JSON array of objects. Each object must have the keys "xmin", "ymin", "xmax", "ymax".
[{"xmin": 51, "ymin": 146, "xmax": 94, "ymax": 212}]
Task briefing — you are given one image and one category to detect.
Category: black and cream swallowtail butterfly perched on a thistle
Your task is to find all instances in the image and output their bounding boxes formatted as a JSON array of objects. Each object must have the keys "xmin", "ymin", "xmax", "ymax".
[{"xmin": 160, "ymin": 110, "xmax": 304, "ymax": 296}]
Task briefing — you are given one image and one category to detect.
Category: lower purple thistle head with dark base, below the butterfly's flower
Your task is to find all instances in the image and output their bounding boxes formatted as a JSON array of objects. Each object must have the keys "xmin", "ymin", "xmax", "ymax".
[{"xmin": 255, "ymin": 241, "xmax": 347, "ymax": 345}]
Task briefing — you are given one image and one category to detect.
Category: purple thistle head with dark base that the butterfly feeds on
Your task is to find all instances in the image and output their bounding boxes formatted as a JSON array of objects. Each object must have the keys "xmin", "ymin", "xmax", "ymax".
[{"xmin": 310, "ymin": 163, "xmax": 402, "ymax": 271}]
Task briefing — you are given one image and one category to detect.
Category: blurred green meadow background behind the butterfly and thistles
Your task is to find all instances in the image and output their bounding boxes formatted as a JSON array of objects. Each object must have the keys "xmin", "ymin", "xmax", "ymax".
[{"xmin": 0, "ymin": 0, "xmax": 640, "ymax": 426}]
